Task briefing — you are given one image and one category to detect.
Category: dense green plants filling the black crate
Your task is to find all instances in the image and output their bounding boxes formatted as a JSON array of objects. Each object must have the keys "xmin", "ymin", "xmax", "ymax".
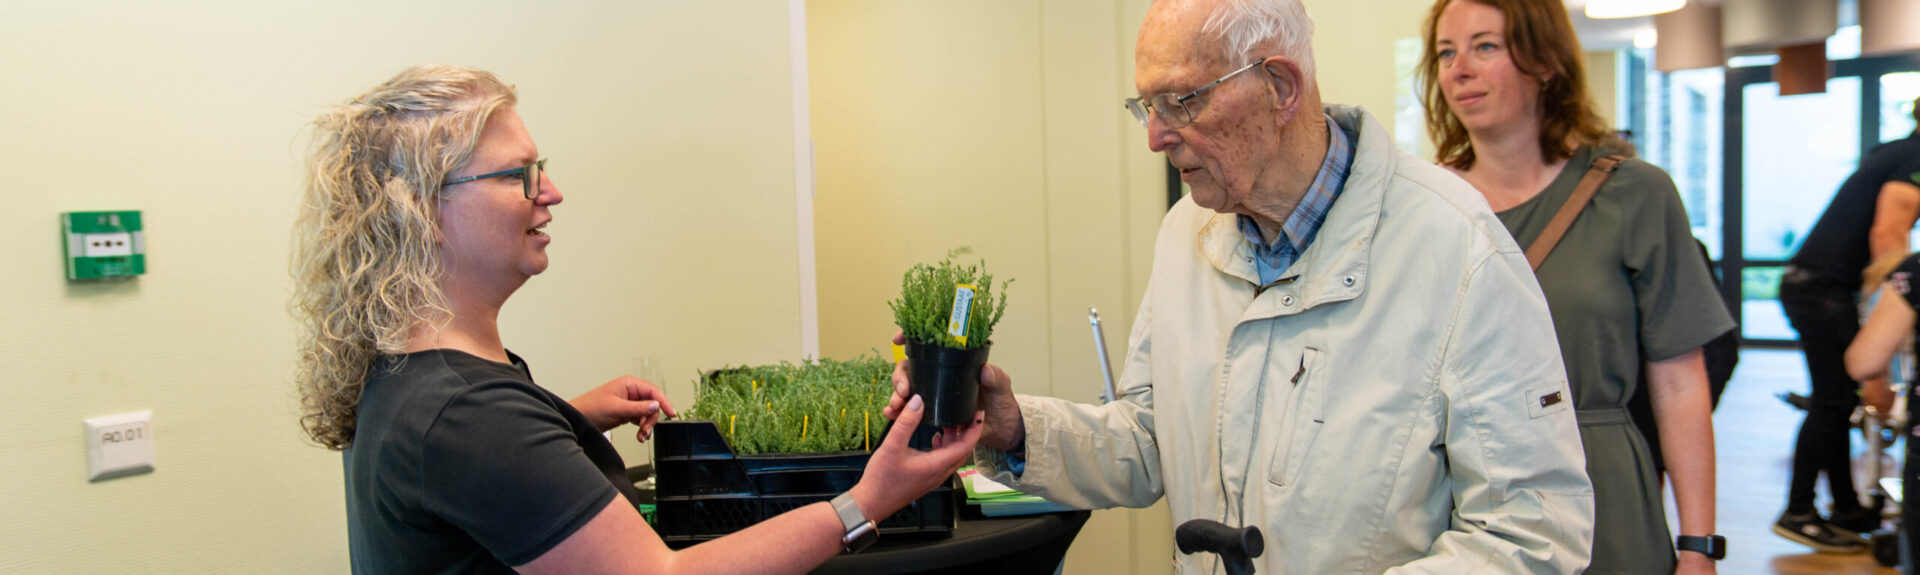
[{"xmin": 687, "ymin": 352, "xmax": 893, "ymax": 456}]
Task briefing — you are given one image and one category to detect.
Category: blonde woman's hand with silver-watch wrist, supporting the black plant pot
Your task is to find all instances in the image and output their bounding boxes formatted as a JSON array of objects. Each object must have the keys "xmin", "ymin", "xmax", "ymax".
[{"xmin": 851, "ymin": 396, "xmax": 985, "ymax": 523}]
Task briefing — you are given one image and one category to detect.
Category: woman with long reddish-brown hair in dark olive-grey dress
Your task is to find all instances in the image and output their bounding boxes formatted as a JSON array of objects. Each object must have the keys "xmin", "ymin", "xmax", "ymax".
[{"xmin": 1421, "ymin": 0, "xmax": 1734, "ymax": 575}]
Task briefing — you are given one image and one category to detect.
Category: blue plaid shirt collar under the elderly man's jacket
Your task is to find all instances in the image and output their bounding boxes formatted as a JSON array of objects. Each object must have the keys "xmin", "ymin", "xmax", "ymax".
[{"xmin": 1240, "ymin": 115, "xmax": 1354, "ymax": 285}]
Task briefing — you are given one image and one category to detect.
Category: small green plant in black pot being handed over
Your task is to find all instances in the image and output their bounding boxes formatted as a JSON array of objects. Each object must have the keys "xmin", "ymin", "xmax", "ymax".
[{"xmin": 887, "ymin": 248, "xmax": 1012, "ymax": 427}]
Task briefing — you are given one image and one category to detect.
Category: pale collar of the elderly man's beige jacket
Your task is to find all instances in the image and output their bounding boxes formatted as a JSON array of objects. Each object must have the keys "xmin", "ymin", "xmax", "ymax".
[{"xmin": 1198, "ymin": 106, "xmax": 1398, "ymax": 310}]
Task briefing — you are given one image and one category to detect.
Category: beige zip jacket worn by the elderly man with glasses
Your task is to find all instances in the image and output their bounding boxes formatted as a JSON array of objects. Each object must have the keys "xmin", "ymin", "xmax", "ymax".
[{"xmin": 975, "ymin": 106, "xmax": 1594, "ymax": 575}]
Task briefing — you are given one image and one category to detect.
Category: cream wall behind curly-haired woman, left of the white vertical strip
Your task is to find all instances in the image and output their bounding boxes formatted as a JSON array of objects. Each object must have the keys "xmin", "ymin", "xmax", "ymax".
[{"xmin": 0, "ymin": 0, "xmax": 801, "ymax": 573}]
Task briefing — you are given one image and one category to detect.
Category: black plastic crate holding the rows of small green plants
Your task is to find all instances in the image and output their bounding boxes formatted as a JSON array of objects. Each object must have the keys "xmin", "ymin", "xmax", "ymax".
[{"xmin": 653, "ymin": 421, "xmax": 960, "ymax": 546}]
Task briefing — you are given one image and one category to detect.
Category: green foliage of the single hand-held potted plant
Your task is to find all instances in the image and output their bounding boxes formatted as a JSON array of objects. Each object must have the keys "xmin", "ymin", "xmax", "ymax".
[{"xmin": 887, "ymin": 248, "xmax": 1014, "ymax": 350}]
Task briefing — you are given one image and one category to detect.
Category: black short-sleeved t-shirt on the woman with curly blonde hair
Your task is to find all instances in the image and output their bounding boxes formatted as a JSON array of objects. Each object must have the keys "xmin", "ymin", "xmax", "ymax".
[{"xmin": 344, "ymin": 350, "xmax": 637, "ymax": 573}]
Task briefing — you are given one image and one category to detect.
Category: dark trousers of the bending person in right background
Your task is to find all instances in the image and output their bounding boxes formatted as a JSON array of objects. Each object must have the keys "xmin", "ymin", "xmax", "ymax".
[{"xmin": 1780, "ymin": 267, "xmax": 1860, "ymax": 513}]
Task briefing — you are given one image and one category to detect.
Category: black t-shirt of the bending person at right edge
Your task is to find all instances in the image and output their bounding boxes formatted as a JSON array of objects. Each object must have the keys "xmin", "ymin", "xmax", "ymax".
[{"xmin": 1791, "ymin": 137, "xmax": 1920, "ymax": 290}]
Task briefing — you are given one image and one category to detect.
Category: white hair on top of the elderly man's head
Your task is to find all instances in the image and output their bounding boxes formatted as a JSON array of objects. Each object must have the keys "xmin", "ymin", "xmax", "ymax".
[{"xmin": 1200, "ymin": 0, "xmax": 1313, "ymax": 83}]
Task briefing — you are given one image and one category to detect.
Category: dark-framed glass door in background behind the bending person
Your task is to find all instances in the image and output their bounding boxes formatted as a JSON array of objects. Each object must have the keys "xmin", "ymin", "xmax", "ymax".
[{"xmin": 1715, "ymin": 56, "xmax": 1920, "ymax": 346}]
